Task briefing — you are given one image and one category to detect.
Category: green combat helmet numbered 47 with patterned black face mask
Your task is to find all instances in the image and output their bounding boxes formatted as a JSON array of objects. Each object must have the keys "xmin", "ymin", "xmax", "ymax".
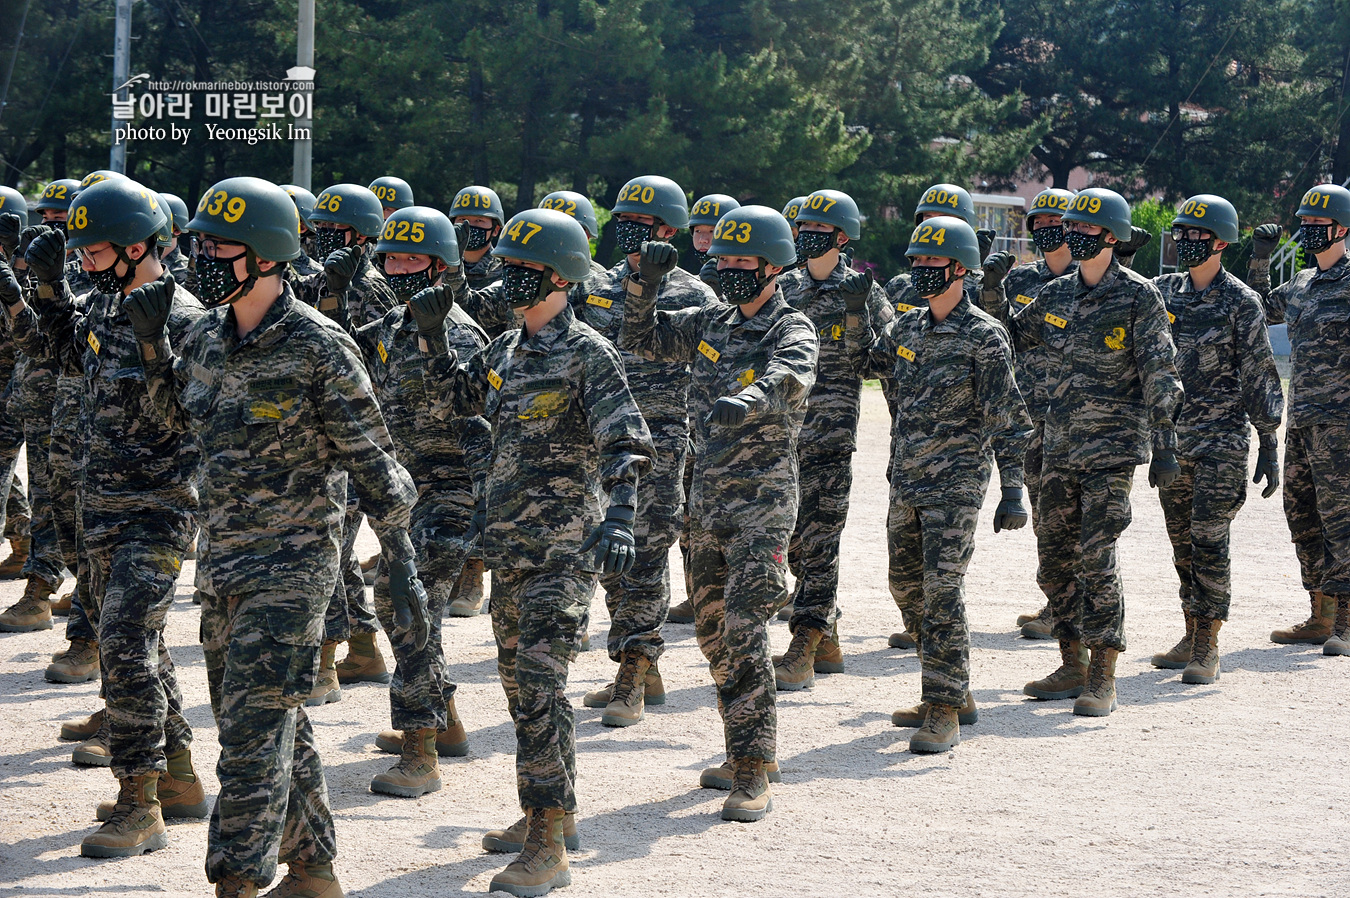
[{"xmin": 493, "ymin": 209, "xmax": 590, "ymax": 309}]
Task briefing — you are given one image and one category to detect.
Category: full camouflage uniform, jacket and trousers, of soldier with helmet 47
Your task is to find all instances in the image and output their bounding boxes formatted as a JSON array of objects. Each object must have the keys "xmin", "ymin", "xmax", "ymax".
[{"xmin": 425, "ymin": 307, "xmax": 653, "ymax": 812}]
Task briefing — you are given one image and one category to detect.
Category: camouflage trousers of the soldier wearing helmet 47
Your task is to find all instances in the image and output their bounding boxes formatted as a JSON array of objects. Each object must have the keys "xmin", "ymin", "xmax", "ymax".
[{"xmin": 491, "ymin": 569, "xmax": 595, "ymax": 812}]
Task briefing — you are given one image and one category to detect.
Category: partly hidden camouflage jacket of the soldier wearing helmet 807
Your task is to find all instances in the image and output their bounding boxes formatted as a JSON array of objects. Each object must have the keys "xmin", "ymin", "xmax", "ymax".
[{"xmin": 778, "ymin": 259, "xmax": 895, "ymax": 452}]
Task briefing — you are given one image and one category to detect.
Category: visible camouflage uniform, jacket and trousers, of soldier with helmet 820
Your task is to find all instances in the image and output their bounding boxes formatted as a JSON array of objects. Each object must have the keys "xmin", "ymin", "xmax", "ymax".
[{"xmin": 570, "ymin": 257, "xmax": 716, "ymax": 664}]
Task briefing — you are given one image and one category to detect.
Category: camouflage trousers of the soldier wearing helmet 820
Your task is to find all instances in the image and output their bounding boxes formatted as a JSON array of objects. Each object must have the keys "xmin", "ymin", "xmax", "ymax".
[{"xmin": 599, "ymin": 421, "xmax": 689, "ymax": 662}]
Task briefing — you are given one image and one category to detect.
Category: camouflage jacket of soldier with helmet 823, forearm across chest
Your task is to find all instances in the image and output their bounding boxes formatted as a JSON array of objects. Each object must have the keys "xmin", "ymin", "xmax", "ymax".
[{"xmin": 620, "ymin": 284, "xmax": 815, "ymax": 531}]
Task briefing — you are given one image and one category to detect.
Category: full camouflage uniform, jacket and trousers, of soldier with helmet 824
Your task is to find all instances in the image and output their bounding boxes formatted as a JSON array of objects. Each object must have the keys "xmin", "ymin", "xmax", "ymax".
[{"xmin": 867, "ymin": 296, "xmax": 1031, "ymax": 708}]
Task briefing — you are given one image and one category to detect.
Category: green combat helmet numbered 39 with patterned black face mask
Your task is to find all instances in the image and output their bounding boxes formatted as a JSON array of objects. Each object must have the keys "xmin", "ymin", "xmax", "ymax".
[{"xmin": 188, "ymin": 177, "xmax": 302, "ymax": 305}]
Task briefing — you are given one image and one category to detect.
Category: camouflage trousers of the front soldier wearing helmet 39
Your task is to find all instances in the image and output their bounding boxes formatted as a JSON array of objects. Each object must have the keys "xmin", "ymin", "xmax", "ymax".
[{"xmin": 201, "ymin": 593, "xmax": 338, "ymax": 886}]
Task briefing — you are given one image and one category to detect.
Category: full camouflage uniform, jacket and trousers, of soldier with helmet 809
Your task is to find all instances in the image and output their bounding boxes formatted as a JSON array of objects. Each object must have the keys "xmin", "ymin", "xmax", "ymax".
[{"xmin": 1011, "ymin": 259, "xmax": 1183, "ymax": 651}]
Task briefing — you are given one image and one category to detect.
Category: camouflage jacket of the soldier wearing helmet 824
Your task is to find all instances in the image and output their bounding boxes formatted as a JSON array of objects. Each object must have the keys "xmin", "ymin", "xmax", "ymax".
[{"xmin": 868, "ymin": 296, "xmax": 1031, "ymax": 508}]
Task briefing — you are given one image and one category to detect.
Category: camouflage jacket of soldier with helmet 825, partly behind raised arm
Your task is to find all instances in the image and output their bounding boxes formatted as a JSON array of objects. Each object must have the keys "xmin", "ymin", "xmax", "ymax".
[{"xmin": 356, "ymin": 304, "xmax": 493, "ymax": 504}]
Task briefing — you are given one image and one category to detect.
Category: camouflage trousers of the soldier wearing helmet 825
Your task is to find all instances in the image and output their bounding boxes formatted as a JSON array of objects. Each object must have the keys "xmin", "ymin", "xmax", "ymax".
[{"xmin": 375, "ymin": 490, "xmax": 474, "ymax": 729}]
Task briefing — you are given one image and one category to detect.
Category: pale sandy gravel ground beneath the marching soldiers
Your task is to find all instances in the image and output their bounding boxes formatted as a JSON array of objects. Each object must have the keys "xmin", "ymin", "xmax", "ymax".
[{"xmin": 0, "ymin": 390, "xmax": 1350, "ymax": 898}]
